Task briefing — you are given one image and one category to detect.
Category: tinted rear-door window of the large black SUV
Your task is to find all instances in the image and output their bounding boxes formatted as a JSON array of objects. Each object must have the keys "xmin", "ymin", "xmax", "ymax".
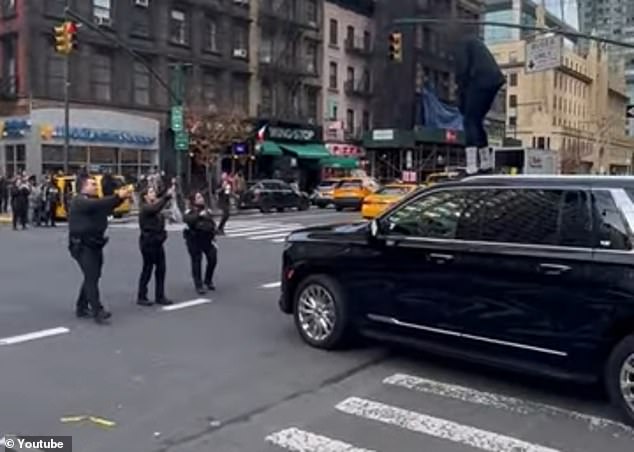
[{"xmin": 481, "ymin": 189, "xmax": 562, "ymax": 245}]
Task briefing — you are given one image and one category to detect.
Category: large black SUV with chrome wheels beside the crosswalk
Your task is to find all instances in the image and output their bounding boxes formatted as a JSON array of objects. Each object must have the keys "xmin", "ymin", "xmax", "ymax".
[{"xmin": 280, "ymin": 176, "xmax": 634, "ymax": 423}]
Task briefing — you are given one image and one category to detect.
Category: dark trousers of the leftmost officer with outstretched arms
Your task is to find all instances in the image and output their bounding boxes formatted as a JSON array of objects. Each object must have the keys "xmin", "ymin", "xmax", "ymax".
[{"xmin": 70, "ymin": 244, "xmax": 103, "ymax": 313}]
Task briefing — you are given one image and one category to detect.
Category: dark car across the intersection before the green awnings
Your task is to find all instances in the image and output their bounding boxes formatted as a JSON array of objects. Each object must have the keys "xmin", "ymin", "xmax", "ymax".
[{"xmin": 238, "ymin": 179, "xmax": 310, "ymax": 213}]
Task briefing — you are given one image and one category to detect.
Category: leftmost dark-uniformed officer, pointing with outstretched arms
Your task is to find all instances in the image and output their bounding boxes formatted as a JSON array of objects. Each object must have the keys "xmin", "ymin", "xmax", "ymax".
[{"xmin": 68, "ymin": 176, "xmax": 132, "ymax": 324}]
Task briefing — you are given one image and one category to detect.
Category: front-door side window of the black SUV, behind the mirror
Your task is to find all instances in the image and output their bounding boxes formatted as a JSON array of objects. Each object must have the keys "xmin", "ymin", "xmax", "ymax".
[{"xmin": 387, "ymin": 190, "xmax": 469, "ymax": 239}]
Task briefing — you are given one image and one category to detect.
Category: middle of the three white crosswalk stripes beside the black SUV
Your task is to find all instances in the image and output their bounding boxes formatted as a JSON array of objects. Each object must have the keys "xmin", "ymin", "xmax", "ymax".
[{"xmin": 336, "ymin": 397, "xmax": 559, "ymax": 452}]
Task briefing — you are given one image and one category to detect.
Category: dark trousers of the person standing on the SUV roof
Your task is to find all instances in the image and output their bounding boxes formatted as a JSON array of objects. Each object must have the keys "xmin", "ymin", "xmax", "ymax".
[{"xmin": 461, "ymin": 86, "xmax": 500, "ymax": 148}]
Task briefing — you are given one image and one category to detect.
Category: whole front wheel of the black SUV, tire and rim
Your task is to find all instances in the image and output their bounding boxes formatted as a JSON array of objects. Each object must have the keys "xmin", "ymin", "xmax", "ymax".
[{"xmin": 293, "ymin": 275, "xmax": 350, "ymax": 350}]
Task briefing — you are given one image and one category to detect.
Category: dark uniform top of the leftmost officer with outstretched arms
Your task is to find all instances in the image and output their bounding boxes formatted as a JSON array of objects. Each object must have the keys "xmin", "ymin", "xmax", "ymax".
[{"xmin": 68, "ymin": 195, "xmax": 123, "ymax": 241}]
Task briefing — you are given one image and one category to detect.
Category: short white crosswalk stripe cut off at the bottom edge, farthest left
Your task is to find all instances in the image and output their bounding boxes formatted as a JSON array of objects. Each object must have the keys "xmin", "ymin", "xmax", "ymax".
[{"xmin": 266, "ymin": 427, "xmax": 375, "ymax": 452}]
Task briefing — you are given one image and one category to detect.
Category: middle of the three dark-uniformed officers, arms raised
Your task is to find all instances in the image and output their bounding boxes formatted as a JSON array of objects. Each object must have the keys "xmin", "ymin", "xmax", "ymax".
[{"xmin": 137, "ymin": 187, "xmax": 174, "ymax": 306}]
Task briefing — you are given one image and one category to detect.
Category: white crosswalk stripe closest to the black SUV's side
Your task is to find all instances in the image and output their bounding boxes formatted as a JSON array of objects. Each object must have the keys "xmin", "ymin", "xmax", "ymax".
[{"xmin": 383, "ymin": 374, "xmax": 634, "ymax": 438}]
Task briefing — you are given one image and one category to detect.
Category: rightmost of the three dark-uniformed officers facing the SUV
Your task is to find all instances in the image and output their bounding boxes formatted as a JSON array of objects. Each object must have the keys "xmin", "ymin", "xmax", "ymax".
[{"xmin": 183, "ymin": 193, "xmax": 218, "ymax": 295}]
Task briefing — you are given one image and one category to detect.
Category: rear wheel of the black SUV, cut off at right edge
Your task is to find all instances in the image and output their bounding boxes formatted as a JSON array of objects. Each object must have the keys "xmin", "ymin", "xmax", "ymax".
[{"xmin": 605, "ymin": 334, "xmax": 634, "ymax": 425}]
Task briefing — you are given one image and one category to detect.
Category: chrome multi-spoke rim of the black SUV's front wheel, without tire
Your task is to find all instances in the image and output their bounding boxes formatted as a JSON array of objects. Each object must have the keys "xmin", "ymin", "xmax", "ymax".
[{"xmin": 297, "ymin": 283, "xmax": 337, "ymax": 342}]
